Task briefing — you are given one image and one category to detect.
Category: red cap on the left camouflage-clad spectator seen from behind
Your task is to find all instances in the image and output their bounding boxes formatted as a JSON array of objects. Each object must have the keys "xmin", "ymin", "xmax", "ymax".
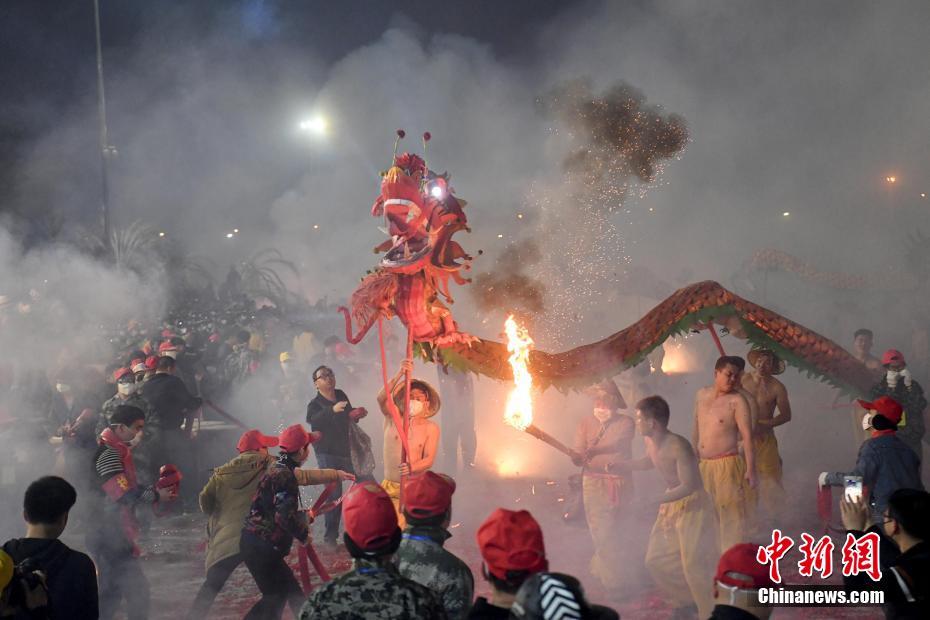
[{"xmin": 342, "ymin": 482, "xmax": 397, "ymax": 551}]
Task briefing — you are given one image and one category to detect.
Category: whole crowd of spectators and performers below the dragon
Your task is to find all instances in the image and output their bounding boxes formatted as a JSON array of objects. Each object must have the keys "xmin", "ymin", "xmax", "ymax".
[{"xmin": 0, "ymin": 318, "xmax": 930, "ymax": 619}]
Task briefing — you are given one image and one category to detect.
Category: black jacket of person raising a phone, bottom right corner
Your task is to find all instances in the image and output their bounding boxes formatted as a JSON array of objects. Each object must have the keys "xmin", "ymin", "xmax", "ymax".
[{"xmin": 843, "ymin": 526, "xmax": 930, "ymax": 620}]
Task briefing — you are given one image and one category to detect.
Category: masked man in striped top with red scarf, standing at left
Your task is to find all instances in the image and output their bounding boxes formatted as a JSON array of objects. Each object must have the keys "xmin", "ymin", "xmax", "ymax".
[{"xmin": 87, "ymin": 405, "xmax": 174, "ymax": 620}]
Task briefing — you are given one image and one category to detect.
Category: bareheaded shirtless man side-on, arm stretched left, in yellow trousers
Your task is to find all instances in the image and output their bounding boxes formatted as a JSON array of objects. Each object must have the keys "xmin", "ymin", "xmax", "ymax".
[{"xmin": 608, "ymin": 396, "xmax": 718, "ymax": 618}]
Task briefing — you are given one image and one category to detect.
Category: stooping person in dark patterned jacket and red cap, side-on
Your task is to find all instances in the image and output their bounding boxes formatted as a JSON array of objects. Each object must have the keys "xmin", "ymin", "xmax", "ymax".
[{"xmin": 239, "ymin": 424, "xmax": 319, "ymax": 618}]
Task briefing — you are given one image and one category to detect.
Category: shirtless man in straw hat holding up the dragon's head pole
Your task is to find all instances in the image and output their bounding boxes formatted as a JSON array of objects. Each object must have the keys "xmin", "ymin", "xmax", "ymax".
[{"xmin": 378, "ymin": 360, "xmax": 440, "ymax": 529}]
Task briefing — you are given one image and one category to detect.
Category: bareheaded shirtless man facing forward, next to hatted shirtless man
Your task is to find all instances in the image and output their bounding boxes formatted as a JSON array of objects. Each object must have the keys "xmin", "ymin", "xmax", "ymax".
[{"xmin": 692, "ymin": 355, "xmax": 756, "ymax": 551}]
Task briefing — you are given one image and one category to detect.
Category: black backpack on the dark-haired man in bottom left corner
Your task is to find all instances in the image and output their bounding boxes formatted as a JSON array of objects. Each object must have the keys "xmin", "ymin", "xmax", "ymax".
[{"xmin": 0, "ymin": 543, "xmax": 68, "ymax": 620}]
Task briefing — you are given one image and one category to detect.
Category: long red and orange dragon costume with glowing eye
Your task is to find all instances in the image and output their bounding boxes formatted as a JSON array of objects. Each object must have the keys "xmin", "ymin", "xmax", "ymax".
[{"xmin": 340, "ymin": 131, "xmax": 874, "ymax": 396}]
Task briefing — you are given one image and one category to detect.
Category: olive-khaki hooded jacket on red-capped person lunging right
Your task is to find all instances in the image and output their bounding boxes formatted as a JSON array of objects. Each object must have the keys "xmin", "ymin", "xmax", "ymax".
[{"xmin": 200, "ymin": 452, "xmax": 339, "ymax": 570}]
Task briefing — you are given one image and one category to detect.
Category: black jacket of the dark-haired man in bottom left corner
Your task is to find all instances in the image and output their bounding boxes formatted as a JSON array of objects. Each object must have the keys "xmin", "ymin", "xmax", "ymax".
[{"xmin": 3, "ymin": 538, "xmax": 99, "ymax": 620}]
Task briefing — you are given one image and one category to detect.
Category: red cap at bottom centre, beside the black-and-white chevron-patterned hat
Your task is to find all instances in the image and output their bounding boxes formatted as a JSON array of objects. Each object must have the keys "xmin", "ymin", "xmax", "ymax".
[{"xmin": 478, "ymin": 508, "xmax": 549, "ymax": 580}]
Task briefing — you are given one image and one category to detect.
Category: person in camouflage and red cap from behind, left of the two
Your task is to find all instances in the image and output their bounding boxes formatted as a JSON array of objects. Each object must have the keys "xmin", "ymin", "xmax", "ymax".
[{"xmin": 299, "ymin": 482, "xmax": 448, "ymax": 620}]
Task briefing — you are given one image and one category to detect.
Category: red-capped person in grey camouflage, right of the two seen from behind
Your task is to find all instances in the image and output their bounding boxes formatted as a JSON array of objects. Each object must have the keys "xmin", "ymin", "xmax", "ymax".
[{"xmin": 394, "ymin": 471, "xmax": 475, "ymax": 620}]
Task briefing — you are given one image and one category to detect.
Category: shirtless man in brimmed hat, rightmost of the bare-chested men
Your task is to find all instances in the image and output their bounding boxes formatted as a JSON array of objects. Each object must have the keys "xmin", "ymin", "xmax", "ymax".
[{"xmin": 742, "ymin": 348, "xmax": 791, "ymax": 525}]
